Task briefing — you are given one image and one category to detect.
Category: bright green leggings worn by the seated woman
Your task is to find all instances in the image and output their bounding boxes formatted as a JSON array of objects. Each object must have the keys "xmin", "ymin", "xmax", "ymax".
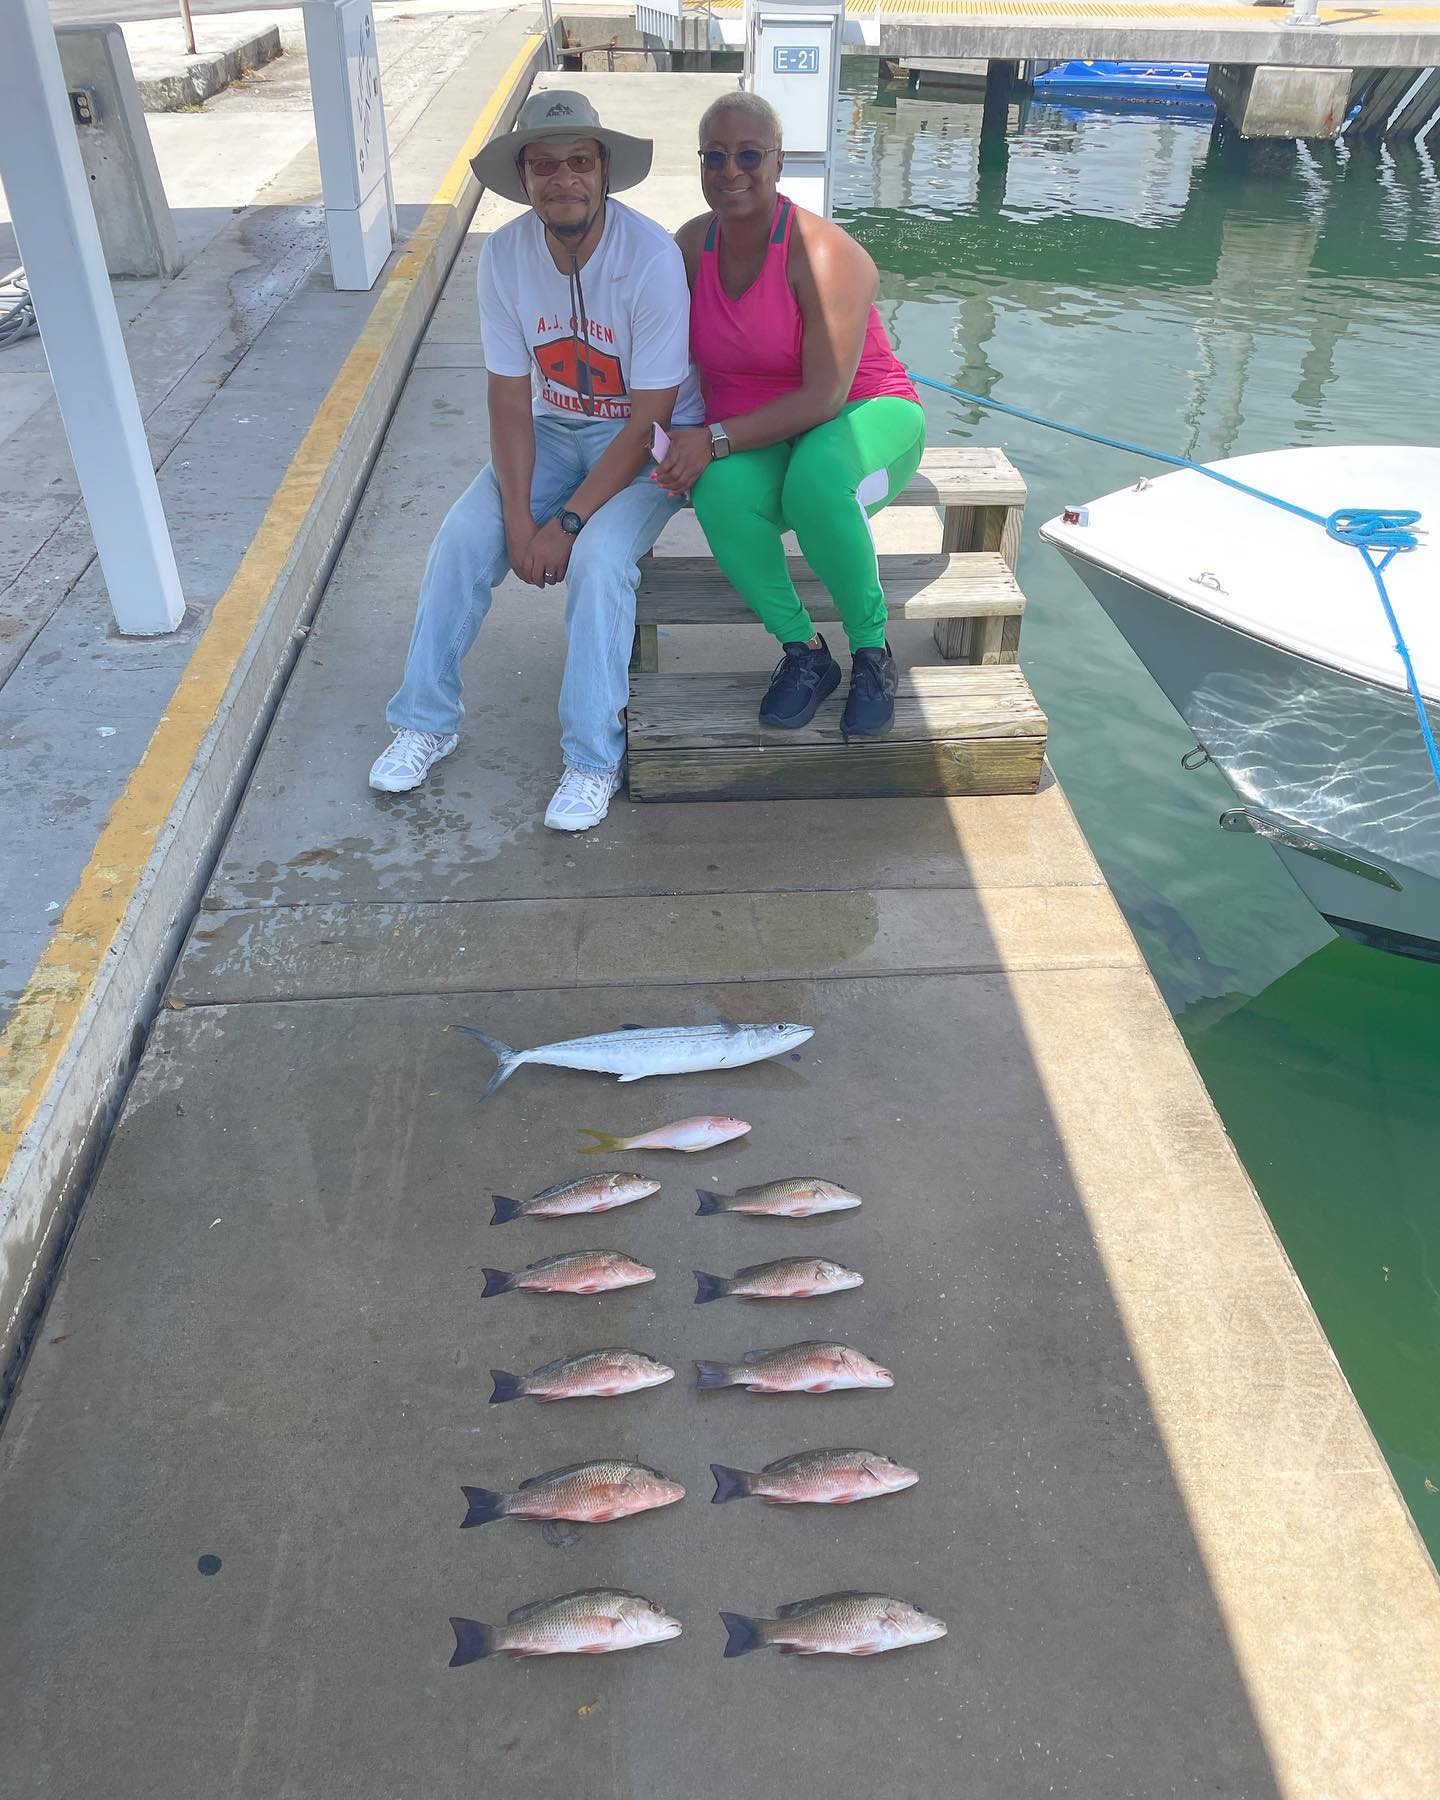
[{"xmin": 693, "ymin": 394, "xmax": 925, "ymax": 650}]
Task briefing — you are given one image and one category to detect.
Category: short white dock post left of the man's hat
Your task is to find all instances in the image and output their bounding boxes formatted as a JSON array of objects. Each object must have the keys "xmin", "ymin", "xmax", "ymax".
[{"xmin": 304, "ymin": 0, "xmax": 394, "ymax": 288}]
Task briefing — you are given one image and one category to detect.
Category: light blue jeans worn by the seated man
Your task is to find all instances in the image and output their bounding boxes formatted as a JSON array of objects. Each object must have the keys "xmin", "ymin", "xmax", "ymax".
[{"xmin": 385, "ymin": 419, "xmax": 680, "ymax": 772}]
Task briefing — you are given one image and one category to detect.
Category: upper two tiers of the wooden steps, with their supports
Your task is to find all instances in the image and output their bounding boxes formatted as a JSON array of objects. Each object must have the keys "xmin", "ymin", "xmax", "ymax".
[{"xmin": 630, "ymin": 446, "xmax": 1026, "ymax": 675}]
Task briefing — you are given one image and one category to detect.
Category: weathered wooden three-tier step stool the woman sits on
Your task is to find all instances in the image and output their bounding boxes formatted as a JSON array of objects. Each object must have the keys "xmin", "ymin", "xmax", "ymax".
[{"xmin": 626, "ymin": 448, "xmax": 1046, "ymax": 801}]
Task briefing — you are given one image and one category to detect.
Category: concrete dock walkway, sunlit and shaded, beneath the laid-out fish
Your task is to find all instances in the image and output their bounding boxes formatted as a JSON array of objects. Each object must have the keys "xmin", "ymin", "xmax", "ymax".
[{"xmin": 0, "ymin": 56, "xmax": 1440, "ymax": 1800}]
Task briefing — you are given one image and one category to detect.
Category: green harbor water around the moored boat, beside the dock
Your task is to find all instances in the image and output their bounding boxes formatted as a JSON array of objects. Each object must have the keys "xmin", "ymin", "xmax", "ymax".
[{"xmin": 835, "ymin": 63, "xmax": 1440, "ymax": 1559}]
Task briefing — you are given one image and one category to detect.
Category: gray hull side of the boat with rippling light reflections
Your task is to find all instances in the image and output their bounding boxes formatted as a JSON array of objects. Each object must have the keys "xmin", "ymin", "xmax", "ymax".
[{"xmin": 1051, "ymin": 558, "xmax": 1440, "ymax": 961}]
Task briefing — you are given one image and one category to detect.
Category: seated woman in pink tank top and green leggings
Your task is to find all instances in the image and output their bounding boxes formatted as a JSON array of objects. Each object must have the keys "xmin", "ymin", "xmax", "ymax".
[{"xmin": 657, "ymin": 94, "xmax": 925, "ymax": 738}]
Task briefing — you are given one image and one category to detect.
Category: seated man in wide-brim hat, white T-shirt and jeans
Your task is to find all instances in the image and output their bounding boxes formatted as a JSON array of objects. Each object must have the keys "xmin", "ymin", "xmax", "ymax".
[{"xmin": 371, "ymin": 88, "xmax": 704, "ymax": 832}]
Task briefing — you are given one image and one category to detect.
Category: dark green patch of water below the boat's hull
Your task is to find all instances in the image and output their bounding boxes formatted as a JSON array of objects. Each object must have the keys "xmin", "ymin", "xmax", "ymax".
[{"xmin": 1181, "ymin": 940, "xmax": 1440, "ymax": 1490}]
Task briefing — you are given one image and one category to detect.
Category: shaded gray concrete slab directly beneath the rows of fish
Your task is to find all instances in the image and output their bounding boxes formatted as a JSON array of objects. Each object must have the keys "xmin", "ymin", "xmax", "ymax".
[{"xmin": 0, "ymin": 986, "xmax": 1274, "ymax": 1800}]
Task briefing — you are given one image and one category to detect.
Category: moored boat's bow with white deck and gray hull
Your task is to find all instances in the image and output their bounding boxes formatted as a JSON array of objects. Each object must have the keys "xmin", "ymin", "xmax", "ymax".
[{"xmin": 1040, "ymin": 446, "xmax": 1440, "ymax": 958}]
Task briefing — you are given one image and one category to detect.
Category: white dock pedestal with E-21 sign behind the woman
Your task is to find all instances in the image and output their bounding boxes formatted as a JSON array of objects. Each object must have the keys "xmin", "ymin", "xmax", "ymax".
[{"xmin": 745, "ymin": 0, "xmax": 844, "ymax": 218}]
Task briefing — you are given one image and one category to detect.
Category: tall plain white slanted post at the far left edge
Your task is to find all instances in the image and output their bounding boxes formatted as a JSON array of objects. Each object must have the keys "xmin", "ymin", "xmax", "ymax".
[{"xmin": 0, "ymin": 0, "xmax": 185, "ymax": 637}]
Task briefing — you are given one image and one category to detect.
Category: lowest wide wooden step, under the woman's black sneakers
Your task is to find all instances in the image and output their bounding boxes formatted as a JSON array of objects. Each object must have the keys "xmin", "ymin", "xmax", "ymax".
[{"xmin": 626, "ymin": 664, "xmax": 1046, "ymax": 801}]
